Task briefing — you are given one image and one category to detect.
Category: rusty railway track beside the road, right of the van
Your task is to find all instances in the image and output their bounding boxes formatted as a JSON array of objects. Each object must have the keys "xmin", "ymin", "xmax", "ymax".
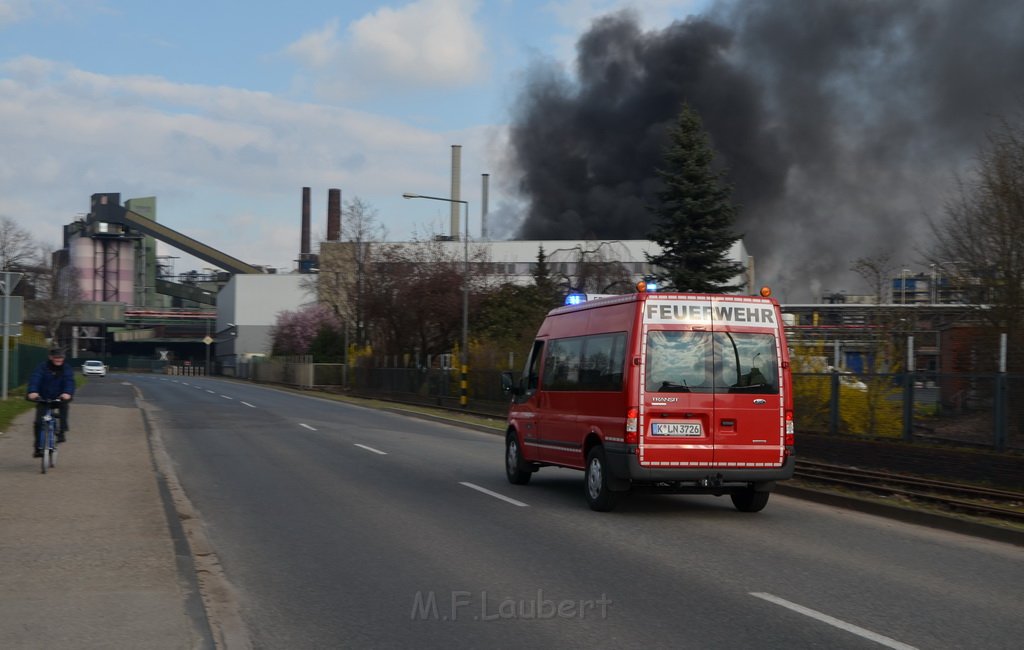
[{"xmin": 795, "ymin": 461, "xmax": 1024, "ymax": 524}]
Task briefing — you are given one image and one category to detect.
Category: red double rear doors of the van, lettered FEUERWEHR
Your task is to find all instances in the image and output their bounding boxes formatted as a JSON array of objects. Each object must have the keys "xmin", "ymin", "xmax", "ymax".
[{"xmin": 639, "ymin": 296, "xmax": 788, "ymax": 467}]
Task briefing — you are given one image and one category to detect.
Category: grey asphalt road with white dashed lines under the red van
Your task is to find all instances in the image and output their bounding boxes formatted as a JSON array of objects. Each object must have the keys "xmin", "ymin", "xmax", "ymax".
[{"xmin": 128, "ymin": 376, "xmax": 1024, "ymax": 648}]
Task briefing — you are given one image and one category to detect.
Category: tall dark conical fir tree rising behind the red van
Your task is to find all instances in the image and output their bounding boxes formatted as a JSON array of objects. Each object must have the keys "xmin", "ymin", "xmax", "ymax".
[{"xmin": 647, "ymin": 104, "xmax": 745, "ymax": 292}]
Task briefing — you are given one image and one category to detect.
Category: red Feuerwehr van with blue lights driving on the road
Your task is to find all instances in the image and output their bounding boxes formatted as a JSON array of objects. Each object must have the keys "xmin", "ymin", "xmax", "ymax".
[{"xmin": 502, "ymin": 291, "xmax": 795, "ymax": 512}]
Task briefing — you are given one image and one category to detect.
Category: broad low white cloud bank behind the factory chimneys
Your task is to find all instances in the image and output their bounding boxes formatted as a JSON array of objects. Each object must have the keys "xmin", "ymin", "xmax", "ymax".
[{"xmin": 0, "ymin": 57, "xmax": 497, "ymax": 270}]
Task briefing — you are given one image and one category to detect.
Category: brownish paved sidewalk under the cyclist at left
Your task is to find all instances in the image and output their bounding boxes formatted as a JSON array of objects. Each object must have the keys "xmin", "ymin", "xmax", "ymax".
[{"xmin": 0, "ymin": 383, "xmax": 213, "ymax": 650}]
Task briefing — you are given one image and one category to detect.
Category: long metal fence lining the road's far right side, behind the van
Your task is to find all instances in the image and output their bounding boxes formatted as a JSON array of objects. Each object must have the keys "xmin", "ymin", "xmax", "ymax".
[{"xmin": 228, "ymin": 356, "xmax": 1024, "ymax": 450}]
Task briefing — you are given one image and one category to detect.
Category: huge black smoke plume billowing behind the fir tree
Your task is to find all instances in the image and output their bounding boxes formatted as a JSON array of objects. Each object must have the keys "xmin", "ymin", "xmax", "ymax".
[{"xmin": 499, "ymin": 0, "xmax": 1024, "ymax": 302}]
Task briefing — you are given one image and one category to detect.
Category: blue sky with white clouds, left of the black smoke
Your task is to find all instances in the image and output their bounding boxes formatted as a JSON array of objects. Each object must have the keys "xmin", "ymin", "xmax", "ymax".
[{"xmin": 0, "ymin": 0, "xmax": 703, "ymax": 272}]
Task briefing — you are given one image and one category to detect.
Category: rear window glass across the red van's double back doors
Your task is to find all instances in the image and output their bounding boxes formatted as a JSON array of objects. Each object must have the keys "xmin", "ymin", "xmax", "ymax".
[{"xmin": 645, "ymin": 330, "xmax": 778, "ymax": 393}]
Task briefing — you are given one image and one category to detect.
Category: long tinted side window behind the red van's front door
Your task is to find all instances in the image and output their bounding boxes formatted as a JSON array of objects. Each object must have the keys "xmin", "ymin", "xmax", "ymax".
[{"xmin": 543, "ymin": 332, "xmax": 626, "ymax": 391}]
